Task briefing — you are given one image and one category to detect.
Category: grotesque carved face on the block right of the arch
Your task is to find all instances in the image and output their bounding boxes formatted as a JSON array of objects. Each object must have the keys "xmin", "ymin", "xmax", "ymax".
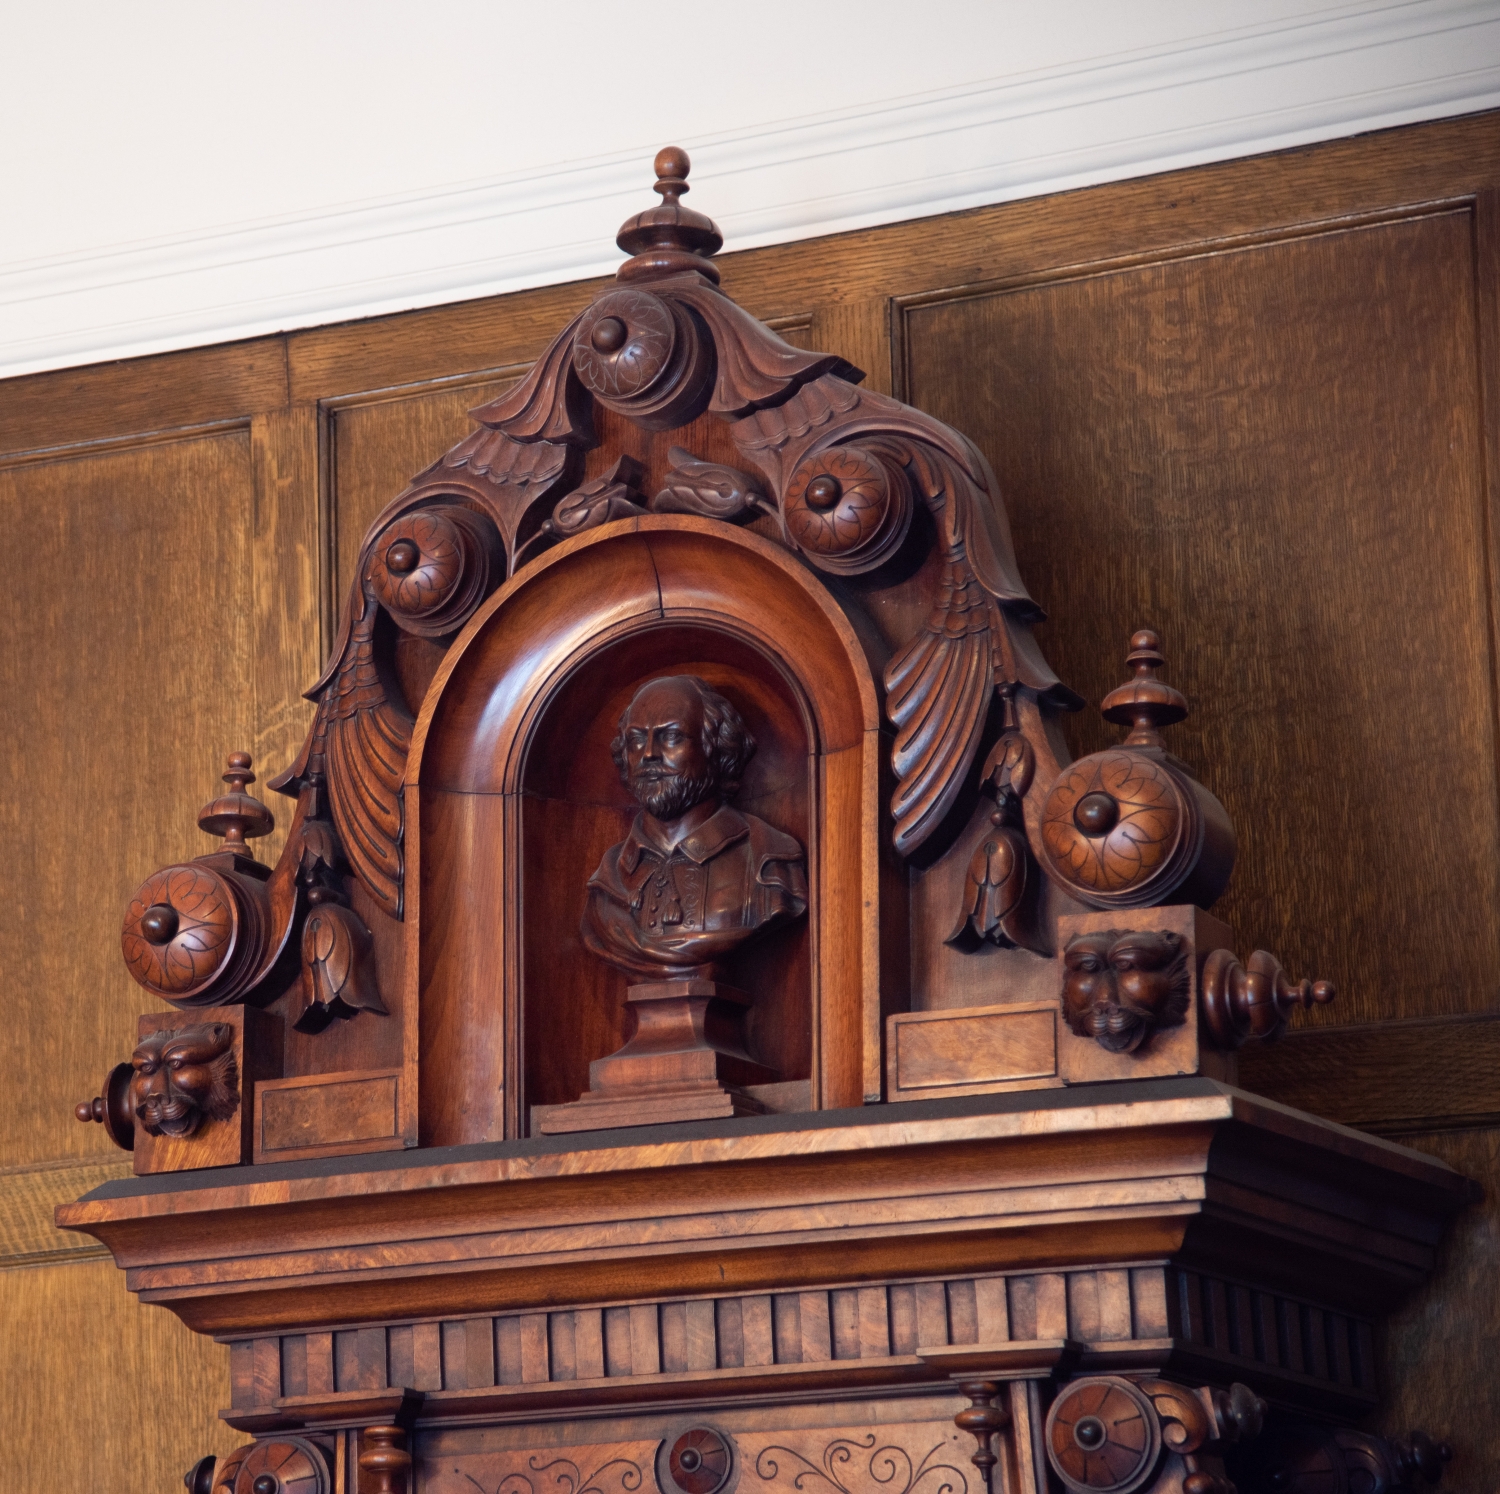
[{"xmin": 1062, "ymin": 929, "xmax": 1190, "ymax": 1053}]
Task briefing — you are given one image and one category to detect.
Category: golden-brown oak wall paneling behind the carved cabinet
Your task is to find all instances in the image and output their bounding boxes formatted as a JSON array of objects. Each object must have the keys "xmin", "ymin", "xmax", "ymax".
[{"xmin": 0, "ymin": 116, "xmax": 1500, "ymax": 1494}]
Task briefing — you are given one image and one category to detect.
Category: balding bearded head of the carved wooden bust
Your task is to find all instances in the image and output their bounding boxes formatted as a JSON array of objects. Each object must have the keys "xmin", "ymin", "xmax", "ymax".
[{"xmin": 611, "ymin": 675, "xmax": 755, "ymax": 821}]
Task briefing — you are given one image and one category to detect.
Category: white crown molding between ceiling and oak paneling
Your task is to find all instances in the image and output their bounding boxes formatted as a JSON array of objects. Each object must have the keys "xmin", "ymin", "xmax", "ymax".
[{"xmin": 0, "ymin": 0, "xmax": 1500, "ymax": 377}]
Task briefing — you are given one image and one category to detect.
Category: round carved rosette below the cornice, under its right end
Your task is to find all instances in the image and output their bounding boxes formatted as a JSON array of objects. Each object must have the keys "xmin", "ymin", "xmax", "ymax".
[{"xmin": 1046, "ymin": 1376, "xmax": 1161, "ymax": 1494}]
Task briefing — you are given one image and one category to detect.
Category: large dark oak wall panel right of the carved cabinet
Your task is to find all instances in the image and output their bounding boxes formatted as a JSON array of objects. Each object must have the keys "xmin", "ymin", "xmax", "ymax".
[{"xmin": 905, "ymin": 209, "xmax": 1500, "ymax": 1023}]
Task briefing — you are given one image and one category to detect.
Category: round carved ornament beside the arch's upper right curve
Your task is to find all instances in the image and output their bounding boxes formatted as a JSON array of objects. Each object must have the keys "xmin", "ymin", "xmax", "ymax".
[{"xmin": 782, "ymin": 446, "xmax": 912, "ymax": 576}]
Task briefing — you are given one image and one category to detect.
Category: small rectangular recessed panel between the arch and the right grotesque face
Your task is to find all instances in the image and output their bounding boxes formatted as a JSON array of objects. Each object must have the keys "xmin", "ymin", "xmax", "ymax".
[{"xmin": 894, "ymin": 1007, "xmax": 1058, "ymax": 1089}]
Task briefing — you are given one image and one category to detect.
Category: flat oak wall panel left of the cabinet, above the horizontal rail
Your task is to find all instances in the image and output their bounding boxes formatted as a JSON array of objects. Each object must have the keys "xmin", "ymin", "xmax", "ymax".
[{"xmin": 0, "ymin": 425, "xmax": 255, "ymax": 1166}]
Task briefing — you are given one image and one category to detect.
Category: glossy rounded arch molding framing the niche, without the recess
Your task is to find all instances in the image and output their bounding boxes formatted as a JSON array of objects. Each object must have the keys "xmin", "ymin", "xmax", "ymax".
[{"xmin": 407, "ymin": 515, "xmax": 881, "ymax": 1145}]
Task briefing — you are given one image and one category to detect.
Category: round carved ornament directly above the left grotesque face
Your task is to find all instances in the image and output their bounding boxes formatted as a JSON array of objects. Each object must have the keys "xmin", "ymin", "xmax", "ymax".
[{"xmin": 120, "ymin": 866, "xmax": 242, "ymax": 1001}]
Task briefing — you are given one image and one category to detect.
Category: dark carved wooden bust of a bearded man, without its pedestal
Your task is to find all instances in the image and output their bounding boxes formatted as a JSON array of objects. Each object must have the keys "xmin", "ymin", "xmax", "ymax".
[{"xmin": 582, "ymin": 675, "xmax": 807, "ymax": 981}]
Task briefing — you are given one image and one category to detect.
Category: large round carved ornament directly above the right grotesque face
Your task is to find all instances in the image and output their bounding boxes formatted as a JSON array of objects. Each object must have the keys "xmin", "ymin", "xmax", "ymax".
[{"xmin": 1041, "ymin": 752, "xmax": 1196, "ymax": 908}]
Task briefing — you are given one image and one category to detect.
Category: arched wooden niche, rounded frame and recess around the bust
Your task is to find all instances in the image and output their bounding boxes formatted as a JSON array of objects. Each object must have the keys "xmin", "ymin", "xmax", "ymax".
[{"xmin": 405, "ymin": 516, "xmax": 881, "ymax": 1145}]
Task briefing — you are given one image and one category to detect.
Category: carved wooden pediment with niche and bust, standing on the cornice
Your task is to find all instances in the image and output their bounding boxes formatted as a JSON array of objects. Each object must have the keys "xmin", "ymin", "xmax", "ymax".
[{"xmin": 64, "ymin": 140, "xmax": 1392, "ymax": 1170}]
